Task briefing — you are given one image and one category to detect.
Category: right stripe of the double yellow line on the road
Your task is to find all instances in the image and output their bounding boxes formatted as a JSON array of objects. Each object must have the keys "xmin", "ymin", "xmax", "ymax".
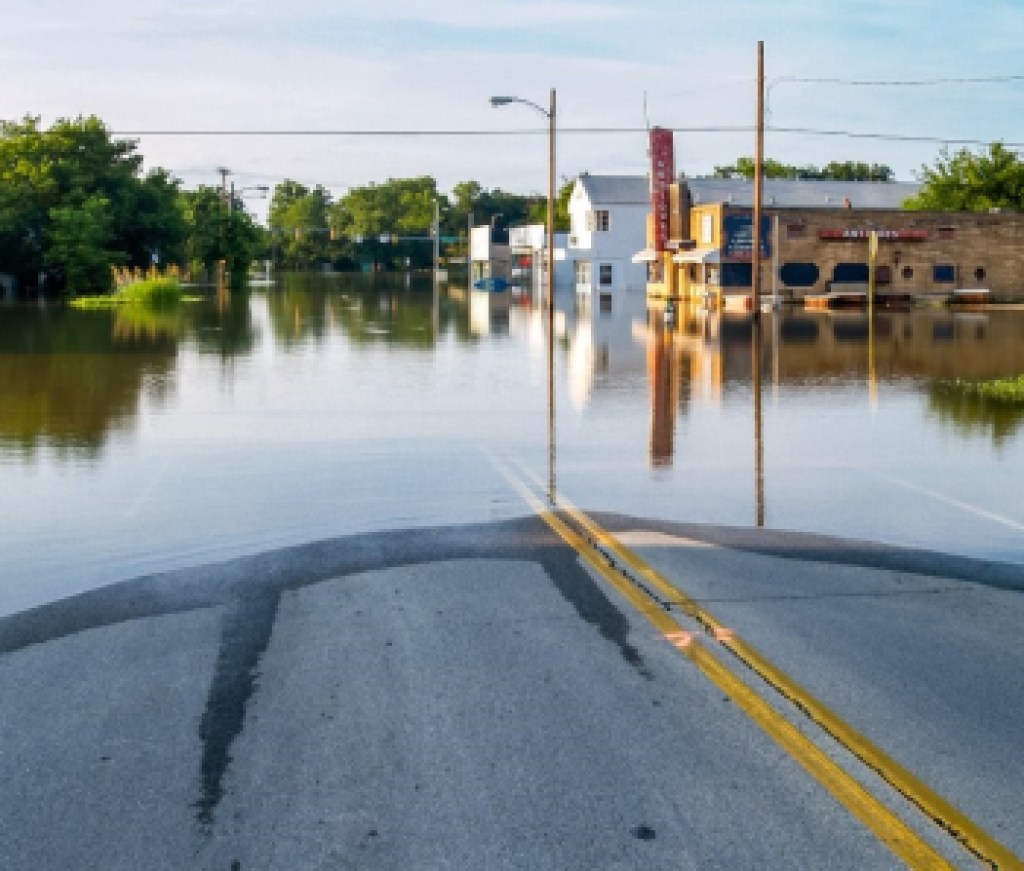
[{"xmin": 562, "ymin": 500, "xmax": 1024, "ymax": 869}]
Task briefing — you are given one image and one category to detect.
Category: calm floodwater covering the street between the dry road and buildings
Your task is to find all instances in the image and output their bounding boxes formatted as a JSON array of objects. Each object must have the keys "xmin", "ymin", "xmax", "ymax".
[{"xmin": 0, "ymin": 275, "xmax": 1024, "ymax": 614}]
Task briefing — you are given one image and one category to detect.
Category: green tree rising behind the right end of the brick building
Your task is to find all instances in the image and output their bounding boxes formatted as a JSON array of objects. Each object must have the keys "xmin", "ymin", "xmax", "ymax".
[{"xmin": 903, "ymin": 142, "xmax": 1024, "ymax": 212}]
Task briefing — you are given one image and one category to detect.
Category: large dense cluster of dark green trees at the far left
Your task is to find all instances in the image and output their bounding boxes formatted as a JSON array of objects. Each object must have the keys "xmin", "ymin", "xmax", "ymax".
[{"xmin": 0, "ymin": 117, "xmax": 262, "ymax": 295}]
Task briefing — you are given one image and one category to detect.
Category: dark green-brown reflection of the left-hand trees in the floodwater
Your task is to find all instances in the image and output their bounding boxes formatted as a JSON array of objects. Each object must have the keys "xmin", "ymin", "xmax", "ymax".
[{"xmin": 0, "ymin": 274, "xmax": 469, "ymax": 458}]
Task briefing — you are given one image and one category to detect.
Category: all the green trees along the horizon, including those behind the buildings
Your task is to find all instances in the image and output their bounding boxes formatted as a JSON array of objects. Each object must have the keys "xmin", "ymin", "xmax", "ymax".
[{"xmin": 0, "ymin": 117, "xmax": 1024, "ymax": 295}]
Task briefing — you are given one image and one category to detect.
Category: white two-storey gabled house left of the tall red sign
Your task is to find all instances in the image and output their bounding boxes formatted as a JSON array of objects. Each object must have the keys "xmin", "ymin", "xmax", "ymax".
[{"xmin": 566, "ymin": 173, "xmax": 650, "ymax": 306}]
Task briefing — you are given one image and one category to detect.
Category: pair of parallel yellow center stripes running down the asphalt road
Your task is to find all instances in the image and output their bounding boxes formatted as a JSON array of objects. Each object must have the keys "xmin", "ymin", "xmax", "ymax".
[{"xmin": 498, "ymin": 463, "xmax": 1024, "ymax": 869}]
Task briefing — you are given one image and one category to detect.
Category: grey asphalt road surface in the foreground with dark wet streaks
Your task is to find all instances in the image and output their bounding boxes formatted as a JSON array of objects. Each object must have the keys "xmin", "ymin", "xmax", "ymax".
[{"xmin": 0, "ymin": 517, "xmax": 1024, "ymax": 871}]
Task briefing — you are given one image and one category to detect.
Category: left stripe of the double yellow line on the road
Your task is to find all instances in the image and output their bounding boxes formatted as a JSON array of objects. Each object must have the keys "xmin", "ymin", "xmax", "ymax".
[{"xmin": 491, "ymin": 460, "xmax": 954, "ymax": 869}]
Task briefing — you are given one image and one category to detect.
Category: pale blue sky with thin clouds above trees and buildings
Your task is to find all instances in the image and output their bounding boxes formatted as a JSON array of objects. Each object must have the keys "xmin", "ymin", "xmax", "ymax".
[{"xmin": 0, "ymin": 0, "xmax": 1024, "ymax": 223}]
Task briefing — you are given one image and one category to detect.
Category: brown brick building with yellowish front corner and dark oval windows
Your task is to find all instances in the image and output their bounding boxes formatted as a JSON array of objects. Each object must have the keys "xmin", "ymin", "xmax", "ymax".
[{"xmin": 648, "ymin": 179, "xmax": 1024, "ymax": 302}]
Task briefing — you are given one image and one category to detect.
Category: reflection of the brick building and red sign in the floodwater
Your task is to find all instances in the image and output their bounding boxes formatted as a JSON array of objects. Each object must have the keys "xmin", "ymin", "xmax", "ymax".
[{"xmin": 634, "ymin": 309, "xmax": 1024, "ymax": 462}]
